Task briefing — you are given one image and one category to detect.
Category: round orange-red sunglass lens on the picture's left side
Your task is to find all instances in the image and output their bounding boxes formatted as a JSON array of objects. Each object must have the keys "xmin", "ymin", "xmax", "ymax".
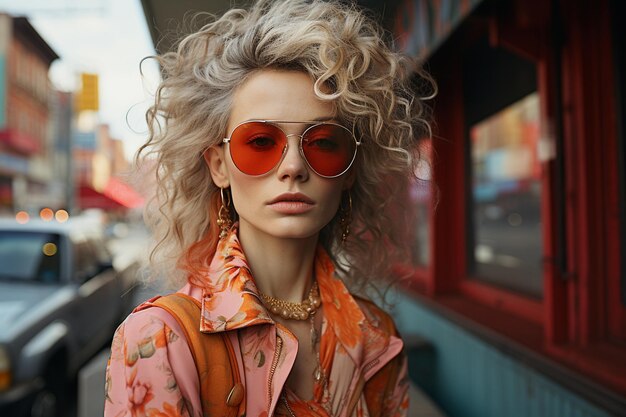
[{"xmin": 230, "ymin": 122, "xmax": 286, "ymax": 175}]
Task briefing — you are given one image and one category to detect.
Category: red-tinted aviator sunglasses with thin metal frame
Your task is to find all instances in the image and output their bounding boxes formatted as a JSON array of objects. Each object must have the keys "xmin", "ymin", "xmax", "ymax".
[{"xmin": 223, "ymin": 120, "xmax": 361, "ymax": 178}]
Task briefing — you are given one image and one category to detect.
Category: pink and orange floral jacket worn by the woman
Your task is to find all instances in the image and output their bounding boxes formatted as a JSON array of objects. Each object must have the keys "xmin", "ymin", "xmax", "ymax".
[{"xmin": 104, "ymin": 231, "xmax": 408, "ymax": 417}]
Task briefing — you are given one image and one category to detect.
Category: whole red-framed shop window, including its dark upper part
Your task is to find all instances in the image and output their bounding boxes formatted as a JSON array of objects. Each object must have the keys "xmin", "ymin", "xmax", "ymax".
[{"xmin": 464, "ymin": 41, "xmax": 543, "ymax": 298}]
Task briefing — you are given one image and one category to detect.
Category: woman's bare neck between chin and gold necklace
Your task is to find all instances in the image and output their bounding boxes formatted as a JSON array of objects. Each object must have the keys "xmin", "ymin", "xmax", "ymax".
[{"xmin": 239, "ymin": 223, "xmax": 318, "ymax": 302}]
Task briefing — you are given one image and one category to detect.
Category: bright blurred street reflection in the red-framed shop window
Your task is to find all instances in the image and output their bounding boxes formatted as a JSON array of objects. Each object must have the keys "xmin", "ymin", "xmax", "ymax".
[{"xmin": 470, "ymin": 92, "xmax": 543, "ymax": 297}]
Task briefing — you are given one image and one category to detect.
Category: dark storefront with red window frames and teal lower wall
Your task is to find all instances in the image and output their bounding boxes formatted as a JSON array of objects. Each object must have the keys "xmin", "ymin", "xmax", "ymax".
[{"xmin": 142, "ymin": 0, "xmax": 626, "ymax": 417}]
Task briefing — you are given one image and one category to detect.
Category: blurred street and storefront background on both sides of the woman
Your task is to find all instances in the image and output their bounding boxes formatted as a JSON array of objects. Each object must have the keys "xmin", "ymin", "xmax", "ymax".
[{"xmin": 0, "ymin": 0, "xmax": 626, "ymax": 417}]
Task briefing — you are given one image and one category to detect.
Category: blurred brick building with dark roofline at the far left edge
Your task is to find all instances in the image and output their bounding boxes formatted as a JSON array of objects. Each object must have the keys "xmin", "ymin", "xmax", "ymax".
[{"xmin": 0, "ymin": 14, "xmax": 63, "ymax": 212}]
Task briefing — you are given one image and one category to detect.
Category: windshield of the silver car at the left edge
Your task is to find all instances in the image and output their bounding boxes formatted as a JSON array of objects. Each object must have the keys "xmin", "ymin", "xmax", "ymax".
[{"xmin": 0, "ymin": 231, "xmax": 61, "ymax": 283}]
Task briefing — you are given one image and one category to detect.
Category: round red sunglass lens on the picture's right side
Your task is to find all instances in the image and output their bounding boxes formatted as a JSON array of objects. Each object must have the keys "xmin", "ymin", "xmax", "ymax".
[{"xmin": 302, "ymin": 124, "xmax": 356, "ymax": 177}]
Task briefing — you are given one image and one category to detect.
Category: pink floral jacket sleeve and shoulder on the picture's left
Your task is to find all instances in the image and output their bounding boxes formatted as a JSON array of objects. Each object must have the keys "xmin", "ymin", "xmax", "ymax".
[{"xmin": 105, "ymin": 290, "xmax": 201, "ymax": 416}]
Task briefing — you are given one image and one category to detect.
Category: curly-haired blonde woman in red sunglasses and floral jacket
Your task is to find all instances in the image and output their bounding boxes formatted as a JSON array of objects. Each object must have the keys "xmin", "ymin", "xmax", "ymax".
[{"xmin": 105, "ymin": 0, "xmax": 428, "ymax": 416}]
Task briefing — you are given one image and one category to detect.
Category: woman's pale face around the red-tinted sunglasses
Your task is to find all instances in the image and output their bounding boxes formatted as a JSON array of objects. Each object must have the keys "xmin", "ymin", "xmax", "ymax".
[{"xmin": 205, "ymin": 70, "xmax": 352, "ymax": 239}]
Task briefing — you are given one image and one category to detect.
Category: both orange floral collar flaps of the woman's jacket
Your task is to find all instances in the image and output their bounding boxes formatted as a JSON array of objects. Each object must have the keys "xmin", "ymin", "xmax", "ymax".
[{"xmin": 200, "ymin": 227, "xmax": 390, "ymax": 363}]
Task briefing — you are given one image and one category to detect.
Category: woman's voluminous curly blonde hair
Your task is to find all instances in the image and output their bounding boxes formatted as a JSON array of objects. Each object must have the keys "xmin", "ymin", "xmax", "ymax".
[{"xmin": 137, "ymin": 0, "xmax": 434, "ymax": 289}]
